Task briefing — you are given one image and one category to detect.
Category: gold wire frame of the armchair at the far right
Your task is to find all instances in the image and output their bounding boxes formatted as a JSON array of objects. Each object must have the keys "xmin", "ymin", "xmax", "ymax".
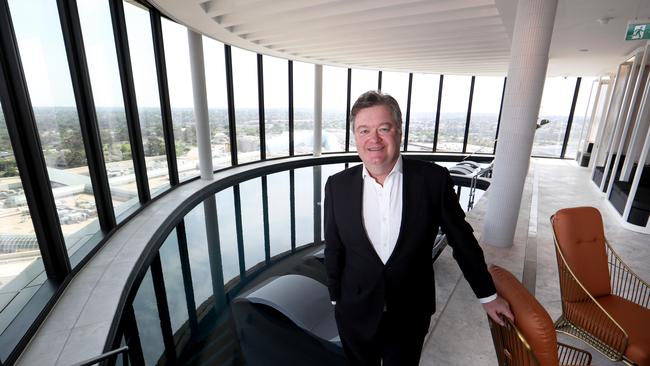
[{"xmin": 551, "ymin": 215, "xmax": 648, "ymax": 365}]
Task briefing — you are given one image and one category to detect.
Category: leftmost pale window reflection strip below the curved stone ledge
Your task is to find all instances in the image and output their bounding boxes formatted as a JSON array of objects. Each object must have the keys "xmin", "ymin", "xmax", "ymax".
[{"xmin": 133, "ymin": 269, "xmax": 165, "ymax": 365}]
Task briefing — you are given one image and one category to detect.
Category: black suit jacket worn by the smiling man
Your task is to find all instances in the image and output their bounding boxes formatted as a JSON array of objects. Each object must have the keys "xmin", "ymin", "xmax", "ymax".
[{"xmin": 324, "ymin": 157, "xmax": 496, "ymax": 339}]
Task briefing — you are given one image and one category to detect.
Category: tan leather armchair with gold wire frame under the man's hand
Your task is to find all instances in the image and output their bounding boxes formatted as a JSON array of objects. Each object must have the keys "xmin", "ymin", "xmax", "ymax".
[{"xmin": 488, "ymin": 266, "xmax": 591, "ymax": 366}]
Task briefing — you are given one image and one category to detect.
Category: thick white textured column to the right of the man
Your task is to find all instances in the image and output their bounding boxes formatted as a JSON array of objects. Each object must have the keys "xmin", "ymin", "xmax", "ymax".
[{"xmin": 481, "ymin": 0, "xmax": 557, "ymax": 247}]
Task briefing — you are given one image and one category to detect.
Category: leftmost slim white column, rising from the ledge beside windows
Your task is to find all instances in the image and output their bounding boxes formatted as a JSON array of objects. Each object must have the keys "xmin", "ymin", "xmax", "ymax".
[{"xmin": 187, "ymin": 29, "xmax": 214, "ymax": 179}]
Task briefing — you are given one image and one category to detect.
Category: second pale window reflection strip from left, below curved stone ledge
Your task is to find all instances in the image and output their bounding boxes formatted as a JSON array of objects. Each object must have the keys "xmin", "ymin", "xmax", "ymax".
[{"xmin": 159, "ymin": 230, "xmax": 189, "ymax": 333}]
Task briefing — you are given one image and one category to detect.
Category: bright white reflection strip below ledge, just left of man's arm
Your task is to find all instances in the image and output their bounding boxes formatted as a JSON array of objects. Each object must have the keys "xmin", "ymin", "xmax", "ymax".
[{"xmin": 295, "ymin": 167, "xmax": 314, "ymax": 247}]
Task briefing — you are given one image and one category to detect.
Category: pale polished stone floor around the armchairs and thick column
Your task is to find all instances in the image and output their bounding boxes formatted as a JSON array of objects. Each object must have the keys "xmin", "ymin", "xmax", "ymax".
[{"xmin": 420, "ymin": 159, "xmax": 650, "ymax": 366}]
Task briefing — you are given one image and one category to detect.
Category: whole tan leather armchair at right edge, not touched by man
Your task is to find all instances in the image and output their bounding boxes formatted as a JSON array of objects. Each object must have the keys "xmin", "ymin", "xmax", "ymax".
[{"xmin": 551, "ymin": 207, "xmax": 650, "ymax": 366}]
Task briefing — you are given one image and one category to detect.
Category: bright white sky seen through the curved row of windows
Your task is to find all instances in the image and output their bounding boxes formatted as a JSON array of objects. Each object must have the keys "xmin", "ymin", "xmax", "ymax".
[{"xmin": 9, "ymin": 0, "xmax": 575, "ymax": 115}]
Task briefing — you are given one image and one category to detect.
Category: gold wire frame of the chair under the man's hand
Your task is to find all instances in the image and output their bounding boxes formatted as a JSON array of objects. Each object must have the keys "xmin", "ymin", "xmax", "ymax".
[{"xmin": 488, "ymin": 317, "xmax": 591, "ymax": 366}]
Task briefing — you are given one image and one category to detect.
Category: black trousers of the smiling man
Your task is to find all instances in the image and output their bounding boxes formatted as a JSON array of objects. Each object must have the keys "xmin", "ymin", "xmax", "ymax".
[{"xmin": 341, "ymin": 312, "xmax": 431, "ymax": 366}]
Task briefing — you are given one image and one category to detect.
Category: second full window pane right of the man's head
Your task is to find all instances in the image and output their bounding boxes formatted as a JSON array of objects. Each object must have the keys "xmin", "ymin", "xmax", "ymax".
[{"xmin": 436, "ymin": 75, "xmax": 472, "ymax": 152}]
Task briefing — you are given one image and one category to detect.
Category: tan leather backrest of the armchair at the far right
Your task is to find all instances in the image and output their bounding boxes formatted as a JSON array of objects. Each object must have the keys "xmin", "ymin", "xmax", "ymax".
[{"xmin": 552, "ymin": 207, "xmax": 612, "ymax": 301}]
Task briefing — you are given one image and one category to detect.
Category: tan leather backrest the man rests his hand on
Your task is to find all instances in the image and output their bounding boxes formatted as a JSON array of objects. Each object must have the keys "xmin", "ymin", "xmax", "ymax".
[{"xmin": 489, "ymin": 265, "xmax": 558, "ymax": 366}]
